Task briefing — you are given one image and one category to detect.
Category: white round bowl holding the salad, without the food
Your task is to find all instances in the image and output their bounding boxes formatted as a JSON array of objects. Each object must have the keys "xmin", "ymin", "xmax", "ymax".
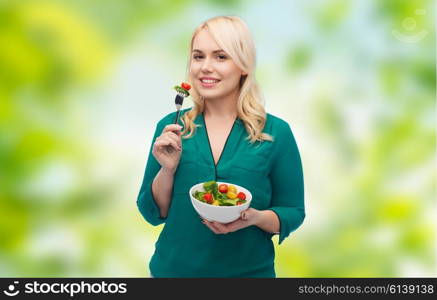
[{"xmin": 189, "ymin": 181, "xmax": 252, "ymax": 223}]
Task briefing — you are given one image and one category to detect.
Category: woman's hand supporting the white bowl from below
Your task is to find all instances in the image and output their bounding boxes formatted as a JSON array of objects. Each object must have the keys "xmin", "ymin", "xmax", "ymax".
[{"xmin": 202, "ymin": 207, "xmax": 261, "ymax": 234}]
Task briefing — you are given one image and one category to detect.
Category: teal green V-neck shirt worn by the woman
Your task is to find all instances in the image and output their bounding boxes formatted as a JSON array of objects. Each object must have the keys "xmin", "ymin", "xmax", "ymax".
[{"xmin": 137, "ymin": 109, "xmax": 305, "ymax": 278}]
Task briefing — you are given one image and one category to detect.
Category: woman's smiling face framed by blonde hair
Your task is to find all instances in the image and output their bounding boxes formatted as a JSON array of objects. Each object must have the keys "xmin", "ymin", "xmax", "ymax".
[{"xmin": 190, "ymin": 29, "xmax": 246, "ymax": 99}]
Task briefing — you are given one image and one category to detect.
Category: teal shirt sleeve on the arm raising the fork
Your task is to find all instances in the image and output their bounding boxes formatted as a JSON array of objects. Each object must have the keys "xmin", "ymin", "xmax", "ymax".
[{"xmin": 137, "ymin": 121, "xmax": 166, "ymax": 226}]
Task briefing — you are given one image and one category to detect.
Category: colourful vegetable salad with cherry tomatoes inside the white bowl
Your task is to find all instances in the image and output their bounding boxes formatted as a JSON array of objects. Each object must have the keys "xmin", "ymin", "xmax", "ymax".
[{"xmin": 193, "ymin": 181, "xmax": 246, "ymax": 206}]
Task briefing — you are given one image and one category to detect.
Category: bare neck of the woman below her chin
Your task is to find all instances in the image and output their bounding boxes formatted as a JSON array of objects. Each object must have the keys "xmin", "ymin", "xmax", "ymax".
[{"xmin": 203, "ymin": 90, "xmax": 239, "ymax": 120}]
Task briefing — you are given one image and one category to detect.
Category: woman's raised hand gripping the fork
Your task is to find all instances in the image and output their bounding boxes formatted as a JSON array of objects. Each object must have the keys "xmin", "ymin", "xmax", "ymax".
[{"xmin": 152, "ymin": 124, "xmax": 182, "ymax": 174}]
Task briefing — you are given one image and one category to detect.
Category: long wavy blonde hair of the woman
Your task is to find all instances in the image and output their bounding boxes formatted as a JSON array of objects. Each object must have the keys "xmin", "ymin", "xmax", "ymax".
[{"xmin": 181, "ymin": 16, "xmax": 273, "ymax": 143}]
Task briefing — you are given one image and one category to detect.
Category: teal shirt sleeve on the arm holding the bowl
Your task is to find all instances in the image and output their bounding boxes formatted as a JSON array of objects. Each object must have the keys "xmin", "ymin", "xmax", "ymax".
[{"xmin": 269, "ymin": 124, "xmax": 305, "ymax": 244}]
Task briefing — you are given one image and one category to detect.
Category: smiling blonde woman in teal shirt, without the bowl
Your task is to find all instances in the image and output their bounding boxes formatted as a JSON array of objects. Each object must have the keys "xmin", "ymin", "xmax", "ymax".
[{"xmin": 137, "ymin": 17, "xmax": 305, "ymax": 278}]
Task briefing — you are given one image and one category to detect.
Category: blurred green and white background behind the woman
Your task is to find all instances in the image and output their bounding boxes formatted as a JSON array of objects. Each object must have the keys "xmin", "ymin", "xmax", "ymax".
[{"xmin": 0, "ymin": 0, "xmax": 437, "ymax": 277}]
